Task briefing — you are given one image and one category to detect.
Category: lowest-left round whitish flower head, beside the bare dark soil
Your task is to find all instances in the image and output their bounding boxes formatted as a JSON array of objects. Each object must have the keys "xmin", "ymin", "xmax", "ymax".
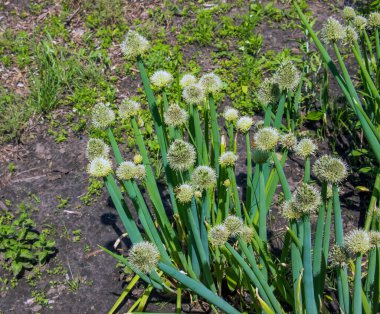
[{"xmin": 128, "ymin": 241, "xmax": 160, "ymax": 274}]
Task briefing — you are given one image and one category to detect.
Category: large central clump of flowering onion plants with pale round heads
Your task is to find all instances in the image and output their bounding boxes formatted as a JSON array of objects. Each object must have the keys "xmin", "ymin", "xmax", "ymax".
[{"xmin": 87, "ymin": 31, "xmax": 380, "ymax": 313}]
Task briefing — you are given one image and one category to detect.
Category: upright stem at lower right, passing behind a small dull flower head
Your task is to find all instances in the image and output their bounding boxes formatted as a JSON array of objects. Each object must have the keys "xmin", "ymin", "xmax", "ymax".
[{"xmin": 332, "ymin": 183, "xmax": 350, "ymax": 313}]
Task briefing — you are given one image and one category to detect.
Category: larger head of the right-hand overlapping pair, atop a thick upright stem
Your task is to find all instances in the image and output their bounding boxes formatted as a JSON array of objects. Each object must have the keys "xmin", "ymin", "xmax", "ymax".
[{"xmin": 293, "ymin": 183, "xmax": 322, "ymax": 215}]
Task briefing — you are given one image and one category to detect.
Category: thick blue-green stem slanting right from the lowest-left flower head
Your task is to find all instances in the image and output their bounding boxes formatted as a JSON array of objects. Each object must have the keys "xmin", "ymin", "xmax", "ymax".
[{"xmin": 158, "ymin": 262, "xmax": 240, "ymax": 314}]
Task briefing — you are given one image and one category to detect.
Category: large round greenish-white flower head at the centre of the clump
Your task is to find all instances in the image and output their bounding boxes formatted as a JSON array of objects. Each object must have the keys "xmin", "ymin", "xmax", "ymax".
[{"xmin": 168, "ymin": 139, "xmax": 196, "ymax": 171}]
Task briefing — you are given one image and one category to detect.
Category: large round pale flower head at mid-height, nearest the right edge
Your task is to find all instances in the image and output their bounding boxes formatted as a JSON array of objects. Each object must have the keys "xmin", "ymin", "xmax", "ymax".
[{"xmin": 313, "ymin": 155, "xmax": 348, "ymax": 183}]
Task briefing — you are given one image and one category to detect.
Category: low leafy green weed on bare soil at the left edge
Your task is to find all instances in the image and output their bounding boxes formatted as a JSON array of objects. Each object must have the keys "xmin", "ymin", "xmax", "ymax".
[{"xmin": 0, "ymin": 204, "xmax": 56, "ymax": 277}]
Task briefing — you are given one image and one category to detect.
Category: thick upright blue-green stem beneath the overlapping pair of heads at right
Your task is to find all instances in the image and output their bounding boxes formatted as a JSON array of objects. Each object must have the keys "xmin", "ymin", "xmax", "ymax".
[{"xmin": 302, "ymin": 215, "xmax": 318, "ymax": 314}]
